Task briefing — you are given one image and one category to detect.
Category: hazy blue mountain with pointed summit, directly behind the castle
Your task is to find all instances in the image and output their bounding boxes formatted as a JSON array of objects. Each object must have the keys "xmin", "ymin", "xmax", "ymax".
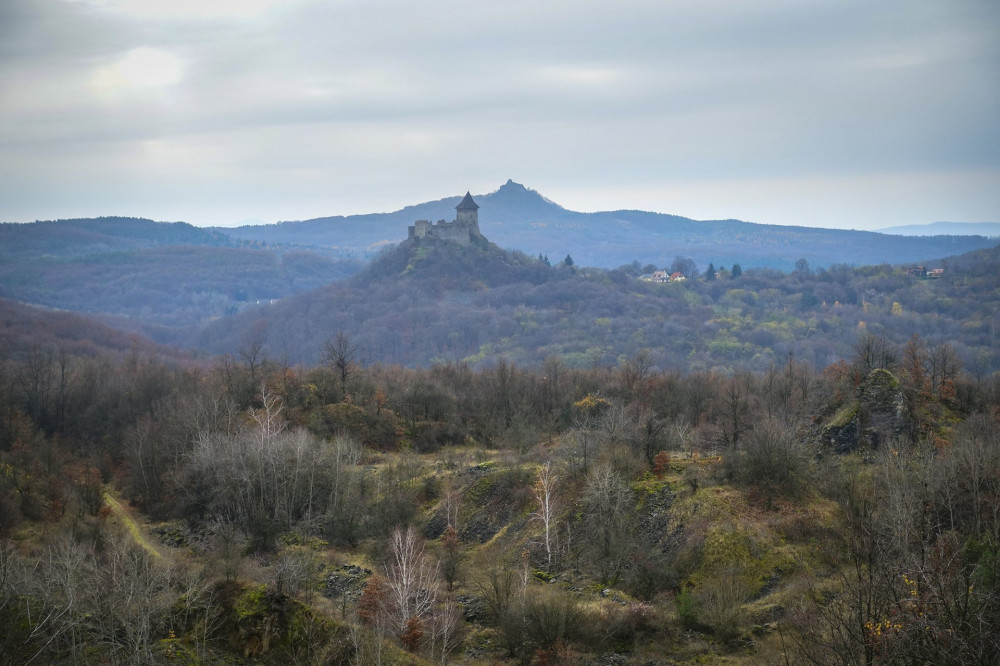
[{"xmin": 219, "ymin": 181, "xmax": 997, "ymax": 270}]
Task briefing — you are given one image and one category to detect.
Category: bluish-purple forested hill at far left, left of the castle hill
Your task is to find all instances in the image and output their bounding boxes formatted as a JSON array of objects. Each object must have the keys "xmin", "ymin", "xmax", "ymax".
[{"xmin": 0, "ymin": 217, "xmax": 360, "ymax": 330}]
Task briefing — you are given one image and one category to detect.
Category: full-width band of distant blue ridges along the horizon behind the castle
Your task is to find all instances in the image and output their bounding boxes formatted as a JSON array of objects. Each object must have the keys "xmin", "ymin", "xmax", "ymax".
[{"xmin": 9, "ymin": 180, "xmax": 1000, "ymax": 271}]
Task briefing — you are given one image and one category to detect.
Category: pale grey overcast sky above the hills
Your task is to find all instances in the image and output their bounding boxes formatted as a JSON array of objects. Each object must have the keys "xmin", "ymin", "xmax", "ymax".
[{"xmin": 0, "ymin": 0, "xmax": 1000, "ymax": 229}]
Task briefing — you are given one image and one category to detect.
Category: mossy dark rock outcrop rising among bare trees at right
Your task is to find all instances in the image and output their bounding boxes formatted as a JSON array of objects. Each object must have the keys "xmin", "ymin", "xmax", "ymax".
[{"xmin": 823, "ymin": 369, "xmax": 909, "ymax": 453}]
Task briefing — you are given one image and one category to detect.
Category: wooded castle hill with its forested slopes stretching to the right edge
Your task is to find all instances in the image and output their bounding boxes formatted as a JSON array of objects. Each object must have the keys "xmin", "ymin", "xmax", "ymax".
[{"xmin": 194, "ymin": 233, "xmax": 1000, "ymax": 370}]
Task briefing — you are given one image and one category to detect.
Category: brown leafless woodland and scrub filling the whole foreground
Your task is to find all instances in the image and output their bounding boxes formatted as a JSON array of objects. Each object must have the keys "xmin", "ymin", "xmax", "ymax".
[{"xmin": 0, "ymin": 320, "xmax": 1000, "ymax": 665}]
